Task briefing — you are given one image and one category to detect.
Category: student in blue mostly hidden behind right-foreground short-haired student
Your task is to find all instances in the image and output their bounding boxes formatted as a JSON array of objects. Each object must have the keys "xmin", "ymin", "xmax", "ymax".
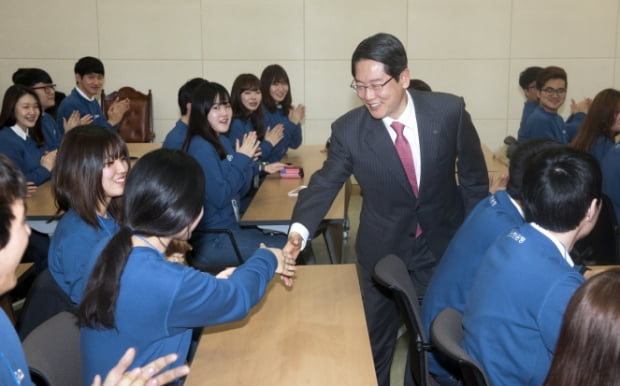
[{"xmin": 421, "ymin": 138, "xmax": 565, "ymax": 383}]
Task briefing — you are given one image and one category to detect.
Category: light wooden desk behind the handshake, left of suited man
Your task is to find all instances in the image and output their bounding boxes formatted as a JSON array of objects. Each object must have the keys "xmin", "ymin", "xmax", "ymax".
[{"xmin": 239, "ymin": 145, "xmax": 346, "ymax": 225}]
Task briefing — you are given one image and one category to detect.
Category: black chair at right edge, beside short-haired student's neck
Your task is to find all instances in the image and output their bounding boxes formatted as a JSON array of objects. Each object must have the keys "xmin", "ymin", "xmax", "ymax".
[{"xmin": 571, "ymin": 194, "xmax": 620, "ymax": 265}]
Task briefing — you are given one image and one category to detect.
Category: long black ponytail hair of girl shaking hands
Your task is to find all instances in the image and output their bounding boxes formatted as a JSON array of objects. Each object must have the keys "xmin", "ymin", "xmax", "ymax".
[{"xmin": 77, "ymin": 149, "xmax": 205, "ymax": 329}]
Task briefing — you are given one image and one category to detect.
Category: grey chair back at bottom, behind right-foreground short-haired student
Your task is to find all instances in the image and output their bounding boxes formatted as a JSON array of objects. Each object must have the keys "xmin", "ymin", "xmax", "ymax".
[{"xmin": 431, "ymin": 308, "xmax": 489, "ymax": 386}]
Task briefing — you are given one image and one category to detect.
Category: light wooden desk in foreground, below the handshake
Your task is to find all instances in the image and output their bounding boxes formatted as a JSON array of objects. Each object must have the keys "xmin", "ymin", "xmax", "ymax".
[{"xmin": 185, "ymin": 264, "xmax": 377, "ymax": 386}]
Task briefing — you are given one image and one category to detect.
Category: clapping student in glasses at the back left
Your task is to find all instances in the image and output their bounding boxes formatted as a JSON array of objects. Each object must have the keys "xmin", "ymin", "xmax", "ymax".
[{"xmin": 13, "ymin": 68, "xmax": 90, "ymax": 150}]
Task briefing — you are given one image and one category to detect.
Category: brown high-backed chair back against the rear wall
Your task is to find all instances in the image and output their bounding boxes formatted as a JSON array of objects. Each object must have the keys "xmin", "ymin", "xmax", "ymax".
[{"xmin": 101, "ymin": 87, "xmax": 155, "ymax": 142}]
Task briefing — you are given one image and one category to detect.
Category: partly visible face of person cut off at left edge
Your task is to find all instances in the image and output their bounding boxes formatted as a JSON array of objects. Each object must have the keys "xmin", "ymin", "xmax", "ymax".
[{"xmin": 0, "ymin": 199, "xmax": 30, "ymax": 294}]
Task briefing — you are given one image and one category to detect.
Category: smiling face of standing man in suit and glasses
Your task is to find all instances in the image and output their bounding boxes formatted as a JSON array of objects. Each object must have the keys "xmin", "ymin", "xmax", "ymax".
[{"xmin": 353, "ymin": 59, "xmax": 409, "ymax": 119}]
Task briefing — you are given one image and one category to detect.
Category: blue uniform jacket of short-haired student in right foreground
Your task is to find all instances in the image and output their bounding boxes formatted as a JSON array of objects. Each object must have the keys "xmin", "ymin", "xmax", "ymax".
[{"xmin": 462, "ymin": 224, "xmax": 584, "ymax": 386}]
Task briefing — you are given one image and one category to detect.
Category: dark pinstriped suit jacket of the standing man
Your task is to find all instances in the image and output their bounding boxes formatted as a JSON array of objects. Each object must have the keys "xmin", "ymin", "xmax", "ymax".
[{"xmin": 292, "ymin": 91, "xmax": 489, "ymax": 270}]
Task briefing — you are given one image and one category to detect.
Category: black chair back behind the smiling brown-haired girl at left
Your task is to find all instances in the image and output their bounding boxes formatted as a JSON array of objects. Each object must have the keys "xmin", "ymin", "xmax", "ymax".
[{"xmin": 17, "ymin": 269, "xmax": 74, "ymax": 340}]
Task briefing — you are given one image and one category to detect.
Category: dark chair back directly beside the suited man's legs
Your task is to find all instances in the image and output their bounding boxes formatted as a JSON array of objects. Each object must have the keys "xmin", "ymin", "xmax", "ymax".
[{"xmin": 374, "ymin": 255, "xmax": 435, "ymax": 386}]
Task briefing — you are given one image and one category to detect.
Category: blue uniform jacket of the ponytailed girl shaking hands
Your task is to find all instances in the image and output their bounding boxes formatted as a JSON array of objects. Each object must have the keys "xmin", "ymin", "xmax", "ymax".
[{"xmin": 81, "ymin": 245, "xmax": 277, "ymax": 384}]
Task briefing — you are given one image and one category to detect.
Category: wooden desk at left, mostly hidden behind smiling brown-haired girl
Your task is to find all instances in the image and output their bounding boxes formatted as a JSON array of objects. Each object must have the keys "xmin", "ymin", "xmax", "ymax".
[{"xmin": 26, "ymin": 142, "xmax": 161, "ymax": 220}]
